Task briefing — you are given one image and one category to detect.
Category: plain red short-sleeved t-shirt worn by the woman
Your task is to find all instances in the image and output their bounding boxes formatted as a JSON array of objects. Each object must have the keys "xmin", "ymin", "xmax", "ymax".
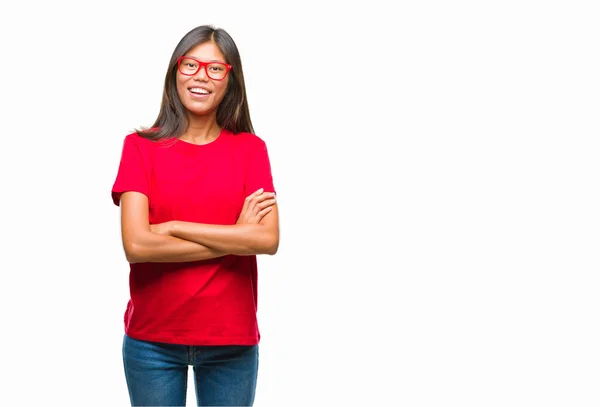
[{"xmin": 112, "ymin": 130, "xmax": 275, "ymax": 345}]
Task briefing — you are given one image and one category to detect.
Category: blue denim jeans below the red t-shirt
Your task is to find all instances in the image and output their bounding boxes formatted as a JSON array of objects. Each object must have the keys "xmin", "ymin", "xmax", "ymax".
[{"xmin": 123, "ymin": 335, "xmax": 258, "ymax": 406}]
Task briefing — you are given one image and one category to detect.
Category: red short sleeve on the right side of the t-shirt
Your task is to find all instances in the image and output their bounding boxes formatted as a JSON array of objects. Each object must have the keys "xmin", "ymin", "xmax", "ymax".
[{"xmin": 245, "ymin": 136, "xmax": 276, "ymax": 196}]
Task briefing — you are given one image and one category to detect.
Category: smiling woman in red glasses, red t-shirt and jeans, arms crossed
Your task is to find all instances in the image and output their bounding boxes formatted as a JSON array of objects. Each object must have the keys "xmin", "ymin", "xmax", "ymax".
[{"xmin": 112, "ymin": 26, "xmax": 279, "ymax": 406}]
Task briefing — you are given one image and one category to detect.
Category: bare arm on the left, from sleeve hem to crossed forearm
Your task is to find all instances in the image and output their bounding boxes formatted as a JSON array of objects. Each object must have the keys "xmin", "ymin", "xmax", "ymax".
[{"xmin": 120, "ymin": 191, "xmax": 228, "ymax": 263}]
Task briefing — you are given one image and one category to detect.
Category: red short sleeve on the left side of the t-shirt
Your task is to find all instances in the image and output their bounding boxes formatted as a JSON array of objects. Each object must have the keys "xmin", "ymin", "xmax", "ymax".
[{"xmin": 111, "ymin": 133, "xmax": 149, "ymax": 206}]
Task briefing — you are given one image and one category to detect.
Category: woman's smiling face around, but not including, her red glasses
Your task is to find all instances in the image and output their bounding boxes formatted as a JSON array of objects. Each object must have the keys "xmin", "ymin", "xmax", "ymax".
[{"xmin": 176, "ymin": 42, "xmax": 229, "ymax": 115}]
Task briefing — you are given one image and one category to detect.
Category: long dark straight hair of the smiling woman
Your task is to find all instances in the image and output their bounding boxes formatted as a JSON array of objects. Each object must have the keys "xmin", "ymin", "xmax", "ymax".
[{"xmin": 136, "ymin": 25, "xmax": 254, "ymax": 140}]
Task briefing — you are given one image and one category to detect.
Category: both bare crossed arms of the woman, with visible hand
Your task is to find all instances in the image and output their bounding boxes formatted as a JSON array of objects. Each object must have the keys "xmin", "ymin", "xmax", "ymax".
[{"xmin": 120, "ymin": 189, "xmax": 279, "ymax": 263}]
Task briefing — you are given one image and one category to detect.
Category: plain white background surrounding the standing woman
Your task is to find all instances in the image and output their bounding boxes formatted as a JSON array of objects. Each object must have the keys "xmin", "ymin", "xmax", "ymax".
[{"xmin": 0, "ymin": 0, "xmax": 600, "ymax": 407}]
